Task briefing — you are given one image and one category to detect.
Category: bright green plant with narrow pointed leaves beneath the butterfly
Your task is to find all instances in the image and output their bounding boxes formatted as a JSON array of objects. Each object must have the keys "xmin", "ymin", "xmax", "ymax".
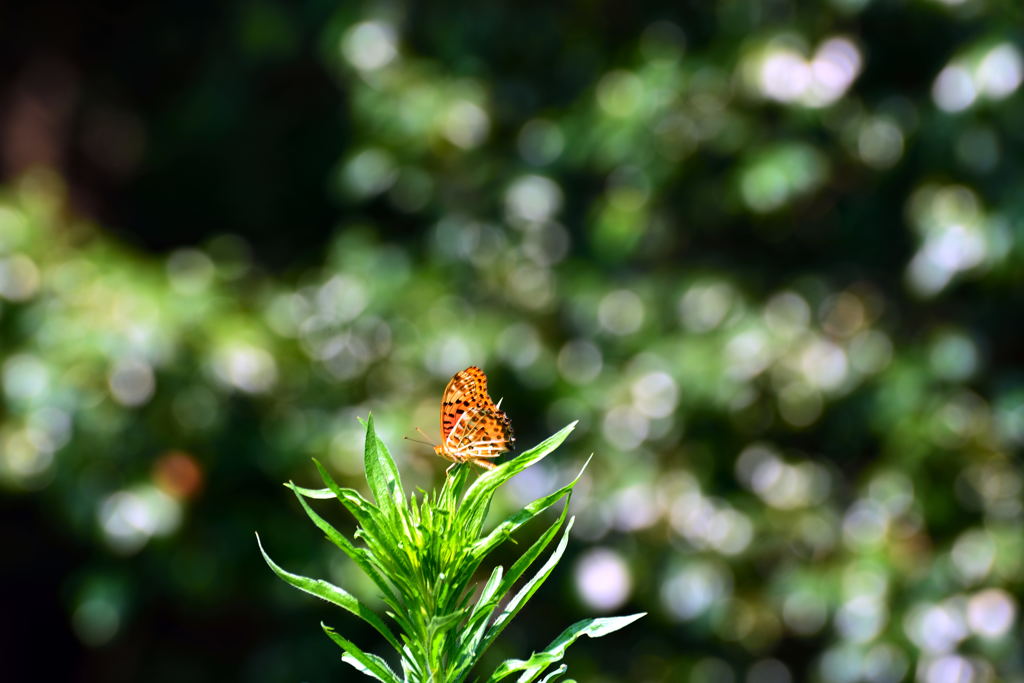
[{"xmin": 257, "ymin": 417, "xmax": 643, "ymax": 683}]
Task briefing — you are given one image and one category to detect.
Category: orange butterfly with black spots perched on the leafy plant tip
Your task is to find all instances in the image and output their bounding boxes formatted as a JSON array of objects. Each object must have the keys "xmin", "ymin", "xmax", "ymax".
[{"xmin": 417, "ymin": 366, "xmax": 515, "ymax": 470}]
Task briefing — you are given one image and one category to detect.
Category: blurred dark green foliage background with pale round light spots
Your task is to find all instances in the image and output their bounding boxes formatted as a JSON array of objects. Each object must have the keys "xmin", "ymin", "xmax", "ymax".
[{"xmin": 0, "ymin": 0, "xmax": 1024, "ymax": 683}]
